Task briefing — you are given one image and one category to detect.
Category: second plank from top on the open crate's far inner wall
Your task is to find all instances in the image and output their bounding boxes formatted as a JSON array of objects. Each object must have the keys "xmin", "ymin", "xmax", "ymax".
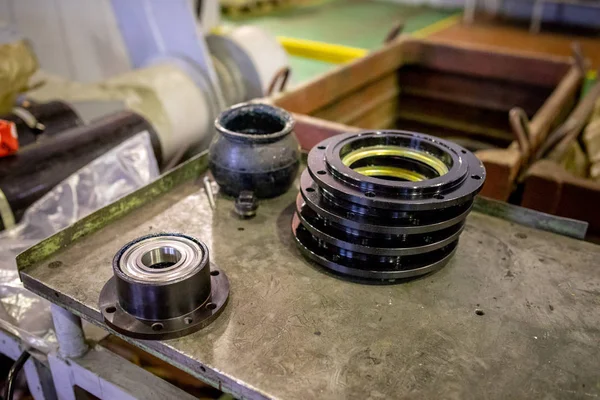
[{"xmin": 398, "ymin": 66, "xmax": 553, "ymax": 116}]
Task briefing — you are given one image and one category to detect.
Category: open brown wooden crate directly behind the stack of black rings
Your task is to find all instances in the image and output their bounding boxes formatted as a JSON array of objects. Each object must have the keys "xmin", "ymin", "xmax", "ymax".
[{"xmin": 270, "ymin": 36, "xmax": 583, "ymax": 200}]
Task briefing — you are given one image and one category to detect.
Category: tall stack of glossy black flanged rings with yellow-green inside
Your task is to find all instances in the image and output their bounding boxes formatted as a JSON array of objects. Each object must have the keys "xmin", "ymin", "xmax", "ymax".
[{"xmin": 292, "ymin": 131, "xmax": 485, "ymax": 282}]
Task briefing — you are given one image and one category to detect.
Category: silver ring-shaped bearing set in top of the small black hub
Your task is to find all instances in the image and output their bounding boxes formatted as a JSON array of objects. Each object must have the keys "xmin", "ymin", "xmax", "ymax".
[{"xmin": 119, "ymin": 236, "xmax": 204, "ymax": 282}]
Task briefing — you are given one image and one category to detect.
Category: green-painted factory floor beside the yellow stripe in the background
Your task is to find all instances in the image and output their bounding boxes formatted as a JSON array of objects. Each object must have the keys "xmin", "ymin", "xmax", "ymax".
[{"xmin": 225, "ymin": 0, "xmax": 456, "ymax": 84}]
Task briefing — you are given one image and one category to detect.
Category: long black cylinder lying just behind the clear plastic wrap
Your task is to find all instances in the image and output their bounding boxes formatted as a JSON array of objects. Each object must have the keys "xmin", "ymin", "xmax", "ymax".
[{"xmin": 0, "ymin": 111, "xmax": 161, "ymax": 228}]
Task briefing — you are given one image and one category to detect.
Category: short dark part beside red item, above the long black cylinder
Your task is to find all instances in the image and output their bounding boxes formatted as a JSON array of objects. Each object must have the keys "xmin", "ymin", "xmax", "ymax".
[{"xmin": 0, "ymin": 100, "xmax": 83, "ymax": 148}]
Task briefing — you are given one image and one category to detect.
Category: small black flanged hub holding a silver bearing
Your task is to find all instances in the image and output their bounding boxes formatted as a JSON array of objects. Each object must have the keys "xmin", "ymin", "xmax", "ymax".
[{"xmin": 99, "ymin": 233, "xmax": 229, "ymax": 340}]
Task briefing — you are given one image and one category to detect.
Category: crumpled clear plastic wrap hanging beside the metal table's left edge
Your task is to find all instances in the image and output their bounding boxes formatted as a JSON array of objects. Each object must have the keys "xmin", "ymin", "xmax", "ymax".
[{"xmin": 0, "ymin": 132, "xmax": 159, "ymax": 353}]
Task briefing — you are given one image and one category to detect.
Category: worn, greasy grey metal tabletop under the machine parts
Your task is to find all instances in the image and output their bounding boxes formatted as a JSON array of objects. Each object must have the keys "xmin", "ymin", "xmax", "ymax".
[{"xmin": 16, "ymin": 180, "xmax": 600, "ymax": 399}]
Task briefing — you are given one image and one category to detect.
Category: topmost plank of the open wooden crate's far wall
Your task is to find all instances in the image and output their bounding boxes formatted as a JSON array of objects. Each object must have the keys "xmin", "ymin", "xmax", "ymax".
[{"xmin": 402, "ymin": 39, "xmax": 570, "ymax": 86}]
